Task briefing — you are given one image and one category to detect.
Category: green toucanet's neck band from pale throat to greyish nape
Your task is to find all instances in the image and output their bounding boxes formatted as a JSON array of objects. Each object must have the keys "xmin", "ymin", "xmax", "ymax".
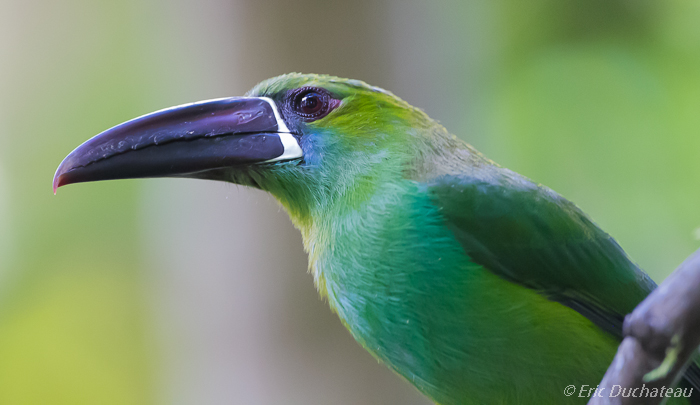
[{"xmin": 258, "ymin": 130, "xmax": 493, "ymax": 290}]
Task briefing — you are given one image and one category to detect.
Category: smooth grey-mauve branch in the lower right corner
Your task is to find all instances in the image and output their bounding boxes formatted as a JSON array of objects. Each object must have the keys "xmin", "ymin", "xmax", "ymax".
[{"xmin": 588, "ymin": 250, "xmax": 700, "ymax": 405}]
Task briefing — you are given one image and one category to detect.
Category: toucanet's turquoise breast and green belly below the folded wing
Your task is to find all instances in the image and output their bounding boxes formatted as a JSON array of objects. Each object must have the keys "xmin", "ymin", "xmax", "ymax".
[{"xmin": 296, "ymin": 175, "xmax": 619, "ymax": 405}]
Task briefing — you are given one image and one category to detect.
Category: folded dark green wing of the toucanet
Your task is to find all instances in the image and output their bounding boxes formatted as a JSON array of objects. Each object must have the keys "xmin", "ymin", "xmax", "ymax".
[{"xmin": 427, "ymin": 168, "xmax": 656, "ymax": 337}]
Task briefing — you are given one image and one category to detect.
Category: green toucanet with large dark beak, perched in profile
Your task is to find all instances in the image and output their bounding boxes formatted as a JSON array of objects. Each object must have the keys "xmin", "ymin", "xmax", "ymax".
[{"xmin": 53, "ymin": 73, "xmax": 700, "ymax": 405}]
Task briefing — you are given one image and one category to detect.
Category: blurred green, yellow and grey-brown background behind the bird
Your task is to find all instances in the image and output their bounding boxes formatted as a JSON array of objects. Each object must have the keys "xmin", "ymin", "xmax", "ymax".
[{"xmin": 0, "ymin": 0, "xmax": 700, "ymax": 404}]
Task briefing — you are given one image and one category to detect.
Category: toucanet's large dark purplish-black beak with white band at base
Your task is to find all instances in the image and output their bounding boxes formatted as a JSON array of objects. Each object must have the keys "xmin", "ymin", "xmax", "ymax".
[{"xmin": 53, "ymin": 97, "xmax": 302, "ymax": 193}]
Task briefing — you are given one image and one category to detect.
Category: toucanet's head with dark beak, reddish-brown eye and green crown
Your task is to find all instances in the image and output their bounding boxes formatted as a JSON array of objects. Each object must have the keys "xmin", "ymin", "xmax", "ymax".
[{"xmin": 53, "ymin": 74, "xmax": 448, "ymax": 226}]
